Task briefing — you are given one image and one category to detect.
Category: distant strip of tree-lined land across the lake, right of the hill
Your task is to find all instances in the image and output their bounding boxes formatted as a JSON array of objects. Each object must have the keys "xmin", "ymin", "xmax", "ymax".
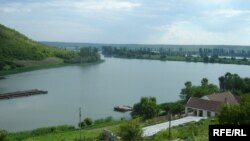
[{"xmin": 102, "ymin": 46, "xmax": 250, "ymax": 65}]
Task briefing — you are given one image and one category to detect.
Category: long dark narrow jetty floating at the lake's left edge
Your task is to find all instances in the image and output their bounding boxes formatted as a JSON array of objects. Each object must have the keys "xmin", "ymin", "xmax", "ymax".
[{"xmin": 0, "ymin": 89, "xmax": 48, "ymax": 100}]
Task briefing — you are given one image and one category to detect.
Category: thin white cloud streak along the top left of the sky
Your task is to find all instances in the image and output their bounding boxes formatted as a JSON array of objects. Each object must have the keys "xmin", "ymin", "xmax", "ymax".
[{"xmin": 0, "ymin": 0, "xmax": 141, "ymax": 13}]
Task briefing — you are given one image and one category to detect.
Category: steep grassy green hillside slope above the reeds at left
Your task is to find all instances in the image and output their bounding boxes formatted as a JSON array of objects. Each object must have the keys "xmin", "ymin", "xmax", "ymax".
[{"xmin": 0, "ymin": 24, "xmax": 77, "ymax": 71}]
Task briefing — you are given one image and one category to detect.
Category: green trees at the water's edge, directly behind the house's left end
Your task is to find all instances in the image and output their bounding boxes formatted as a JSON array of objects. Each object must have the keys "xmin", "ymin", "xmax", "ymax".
[{"xmin": 180, "ymin": 78, "xmax": 218, "ymax": 101}]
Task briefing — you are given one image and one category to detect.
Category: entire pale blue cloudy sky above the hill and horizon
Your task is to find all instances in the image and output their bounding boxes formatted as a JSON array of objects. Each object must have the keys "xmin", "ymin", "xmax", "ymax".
[{"xmin": 0, "ymin": 0, "xmax": 250, "ymax": 45}]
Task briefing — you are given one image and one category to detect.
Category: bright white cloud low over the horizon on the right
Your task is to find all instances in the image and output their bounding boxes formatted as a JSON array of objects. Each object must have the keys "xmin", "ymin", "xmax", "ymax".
[{"xmin": 147, "ymin": 21, "xmax": 250, "ymax": 45}]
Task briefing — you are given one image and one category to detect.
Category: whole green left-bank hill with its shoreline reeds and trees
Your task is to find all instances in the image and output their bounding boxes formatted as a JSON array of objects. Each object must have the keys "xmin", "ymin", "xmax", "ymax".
[{"xmin": 0, "ymin": 25, "xmax": 101, "ymax": 76}]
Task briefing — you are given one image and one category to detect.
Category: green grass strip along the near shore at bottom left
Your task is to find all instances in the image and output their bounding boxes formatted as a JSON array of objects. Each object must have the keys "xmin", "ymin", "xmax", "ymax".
[{"xmin": 8, "ymin": 120, "xmax": 125, "ymax": 141}]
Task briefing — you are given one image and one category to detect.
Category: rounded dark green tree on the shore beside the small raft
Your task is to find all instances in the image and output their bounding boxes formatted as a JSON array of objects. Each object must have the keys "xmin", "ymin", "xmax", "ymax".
[{"xmin": 131, "ymin": 97, "xmax": 159, "ymax": 119}]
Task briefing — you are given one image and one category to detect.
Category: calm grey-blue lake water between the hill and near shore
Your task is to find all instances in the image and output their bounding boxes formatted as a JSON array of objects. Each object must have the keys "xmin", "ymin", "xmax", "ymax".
[{"xmin": 0, "ymin": 58, "xmax": 250, "ymax": 131}]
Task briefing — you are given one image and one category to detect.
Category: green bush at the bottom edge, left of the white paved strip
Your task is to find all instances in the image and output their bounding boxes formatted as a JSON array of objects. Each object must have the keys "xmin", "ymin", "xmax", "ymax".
[{"xmin": 119, "ymin": 119, "xmax": 142, "ymax": 141}]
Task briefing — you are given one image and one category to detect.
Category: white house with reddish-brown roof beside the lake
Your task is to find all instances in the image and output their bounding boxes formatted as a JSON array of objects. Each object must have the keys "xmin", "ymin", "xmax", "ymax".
[{"xmin": 185, "ymin": 92, "xmax": 240, "ymax": 117}]
